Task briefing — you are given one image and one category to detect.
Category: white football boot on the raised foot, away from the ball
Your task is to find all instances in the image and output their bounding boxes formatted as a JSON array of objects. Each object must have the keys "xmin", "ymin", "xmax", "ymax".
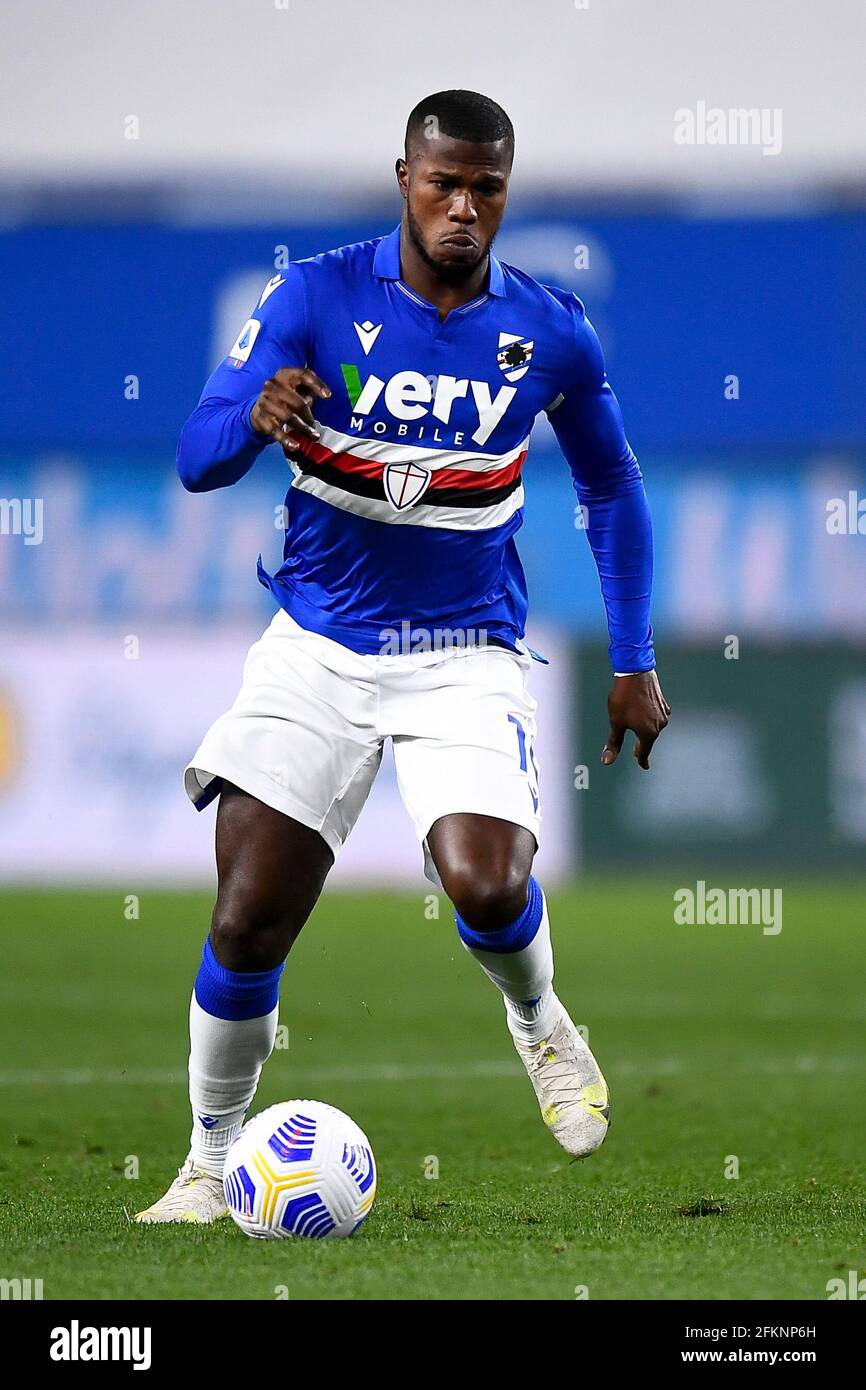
[{"xmin": 512, "ymin": 999, "xmax": 610, "ymax": 1158}]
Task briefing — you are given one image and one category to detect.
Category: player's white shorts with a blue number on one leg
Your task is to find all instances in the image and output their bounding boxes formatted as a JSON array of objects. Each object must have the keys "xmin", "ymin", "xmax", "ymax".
[{"xmin": 183, "ymin": 609, "xmax": 541, "ymax": 884}]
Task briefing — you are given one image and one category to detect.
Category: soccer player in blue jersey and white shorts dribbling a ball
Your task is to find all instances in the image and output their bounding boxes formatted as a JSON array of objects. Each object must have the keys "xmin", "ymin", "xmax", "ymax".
[{"xmin": 138, "ymin": 90, "xmax": 670, "ymax": 1222}]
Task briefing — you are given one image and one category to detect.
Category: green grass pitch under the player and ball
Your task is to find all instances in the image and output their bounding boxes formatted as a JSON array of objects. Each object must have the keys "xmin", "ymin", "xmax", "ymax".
[{"xmin": 0, "ymin": 877, "xmax": 866, "ymax": 1300}]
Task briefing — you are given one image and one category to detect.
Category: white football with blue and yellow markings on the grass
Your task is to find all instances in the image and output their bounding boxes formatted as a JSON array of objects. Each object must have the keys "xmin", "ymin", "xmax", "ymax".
[{"xmin": 222, "ymin": 1101, "xmax": 377, "ymax": 1240}]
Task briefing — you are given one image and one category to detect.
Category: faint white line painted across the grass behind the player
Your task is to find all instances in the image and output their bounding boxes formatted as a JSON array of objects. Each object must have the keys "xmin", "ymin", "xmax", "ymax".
[{"xmin": 0, "ymin": 1052, "xmax": 866, "ymax": 1087}]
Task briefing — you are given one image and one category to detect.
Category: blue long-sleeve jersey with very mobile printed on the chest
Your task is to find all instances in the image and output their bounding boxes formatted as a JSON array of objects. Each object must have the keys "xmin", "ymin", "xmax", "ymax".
[{"xmin": 178, "ymin": 227, "xmax": 655, "ymax": 671}]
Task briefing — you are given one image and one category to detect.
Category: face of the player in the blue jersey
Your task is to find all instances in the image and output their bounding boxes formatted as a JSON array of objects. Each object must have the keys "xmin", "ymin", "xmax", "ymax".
[{"xmin": 398, "ymin": 136, "xmax": 512, "ymax": 278}]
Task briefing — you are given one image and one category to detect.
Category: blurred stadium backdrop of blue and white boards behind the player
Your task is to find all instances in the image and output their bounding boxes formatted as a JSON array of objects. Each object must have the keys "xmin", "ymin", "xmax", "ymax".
[{"xmin": 0, "ymin": 0, "xmax": 866, "ymax": 885}]
